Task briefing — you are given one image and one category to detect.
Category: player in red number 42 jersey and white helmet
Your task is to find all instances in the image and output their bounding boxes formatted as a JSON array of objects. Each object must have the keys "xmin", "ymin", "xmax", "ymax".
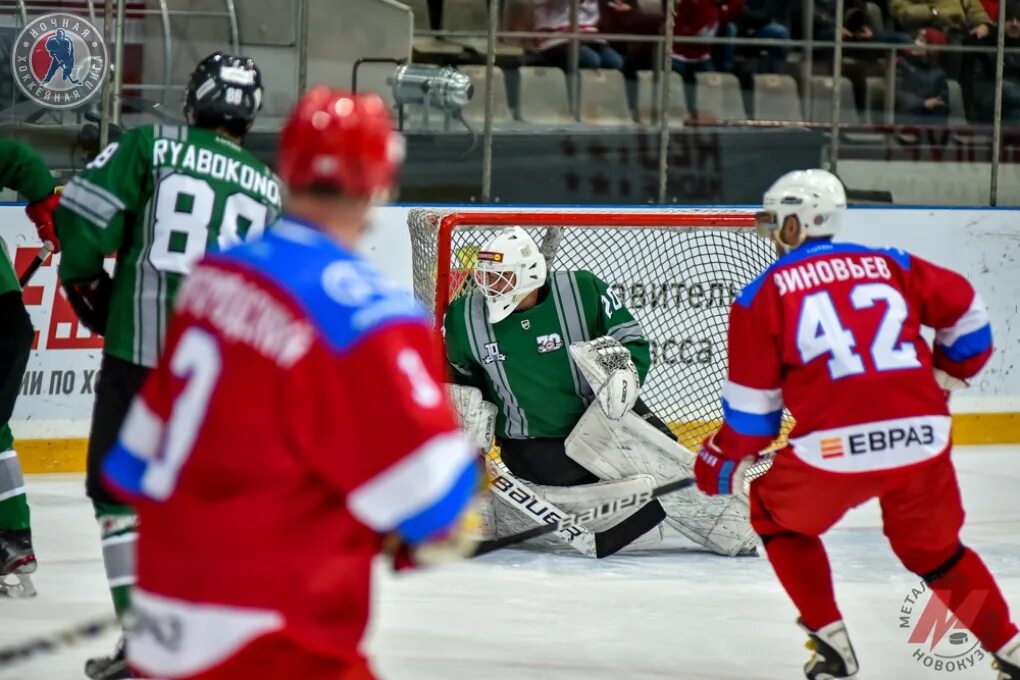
[{"xmin": 695, "ymin": 170, "xmax": 1020, "ymax": 680}]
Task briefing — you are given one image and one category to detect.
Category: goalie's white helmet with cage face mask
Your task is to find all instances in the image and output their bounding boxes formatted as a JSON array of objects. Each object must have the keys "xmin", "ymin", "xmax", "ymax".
[{"xmin": 474, "ymin": 226, "xmax": 546, "ymax": 323}]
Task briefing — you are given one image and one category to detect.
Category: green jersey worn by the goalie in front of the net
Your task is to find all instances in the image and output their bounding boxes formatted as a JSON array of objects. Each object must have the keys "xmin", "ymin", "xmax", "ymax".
[{"xmin": 444, "ymin": 271, "xmax": 652, "ymax": 438}]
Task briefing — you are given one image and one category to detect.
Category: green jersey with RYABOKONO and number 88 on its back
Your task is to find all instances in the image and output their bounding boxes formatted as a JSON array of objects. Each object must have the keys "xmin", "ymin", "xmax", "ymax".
[{"xmin": 55, "ymin": 125, "xmax": 281, "ymax": 366}]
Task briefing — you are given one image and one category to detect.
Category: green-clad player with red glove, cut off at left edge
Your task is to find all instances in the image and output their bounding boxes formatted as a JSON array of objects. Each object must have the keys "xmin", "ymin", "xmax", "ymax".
[{"xmin": 0, "ymin": 140, "xmax": 60, "ymax": 596}]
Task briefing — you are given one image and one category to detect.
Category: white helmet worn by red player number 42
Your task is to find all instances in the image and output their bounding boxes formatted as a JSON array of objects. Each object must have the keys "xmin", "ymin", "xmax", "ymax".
[{"xmin": 755, "ymin": 169, "xmax": 847, "ymax": 251}]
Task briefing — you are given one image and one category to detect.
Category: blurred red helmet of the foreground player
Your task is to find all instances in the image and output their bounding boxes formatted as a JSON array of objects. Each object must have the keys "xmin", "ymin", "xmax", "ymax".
[{"xmin": 276, "ymin": 86, "xmax": 404, "ymax": 199}]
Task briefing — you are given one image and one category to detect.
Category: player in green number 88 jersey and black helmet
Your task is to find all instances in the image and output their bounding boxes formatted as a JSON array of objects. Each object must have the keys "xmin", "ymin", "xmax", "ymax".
[{"xmin": 56, "ymin": 52, "xmax": 281, "ymax": 678}]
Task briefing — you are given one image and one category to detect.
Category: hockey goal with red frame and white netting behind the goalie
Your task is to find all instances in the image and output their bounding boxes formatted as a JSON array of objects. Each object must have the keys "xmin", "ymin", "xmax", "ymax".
[{"xmin": 408, "ymin": 208, "xmax": 775, "ymax": 448}]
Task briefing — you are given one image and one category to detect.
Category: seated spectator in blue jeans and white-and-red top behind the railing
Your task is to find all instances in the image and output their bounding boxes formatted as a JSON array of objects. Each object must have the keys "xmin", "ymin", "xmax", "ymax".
[{"xmin": 532, "ymin": 0, "xmax": 631, "ymax": 70}]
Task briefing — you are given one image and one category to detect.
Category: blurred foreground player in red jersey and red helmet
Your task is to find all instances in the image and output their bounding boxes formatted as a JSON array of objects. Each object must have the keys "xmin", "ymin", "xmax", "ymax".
[{"xmin": 105, "ymin": 88, "xmax": 479, "ymax": 680}]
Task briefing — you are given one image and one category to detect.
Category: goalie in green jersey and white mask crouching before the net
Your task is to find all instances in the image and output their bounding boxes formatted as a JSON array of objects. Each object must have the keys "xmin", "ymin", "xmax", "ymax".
[{"xmin": 444, "ymin": 227, "xmax": 757, "ymax": 557}]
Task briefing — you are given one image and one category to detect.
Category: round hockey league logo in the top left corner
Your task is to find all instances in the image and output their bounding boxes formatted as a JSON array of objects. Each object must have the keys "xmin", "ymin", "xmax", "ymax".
[{"xmin": 10, "ymin": 12, "xmax": 109, "ymax": 109}]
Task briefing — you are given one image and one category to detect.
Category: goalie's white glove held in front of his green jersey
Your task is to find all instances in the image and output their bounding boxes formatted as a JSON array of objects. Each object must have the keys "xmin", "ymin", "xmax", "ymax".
[{"xmin": 570, "ymin": 335, "xmax": 641, "ymax": 420}]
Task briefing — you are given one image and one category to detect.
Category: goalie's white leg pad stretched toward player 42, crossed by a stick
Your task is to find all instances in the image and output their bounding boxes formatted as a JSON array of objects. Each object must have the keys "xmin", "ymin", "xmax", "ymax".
[{"xmin": 566, "ymin": 404, "xmax": 758, "ymax": 556}]
